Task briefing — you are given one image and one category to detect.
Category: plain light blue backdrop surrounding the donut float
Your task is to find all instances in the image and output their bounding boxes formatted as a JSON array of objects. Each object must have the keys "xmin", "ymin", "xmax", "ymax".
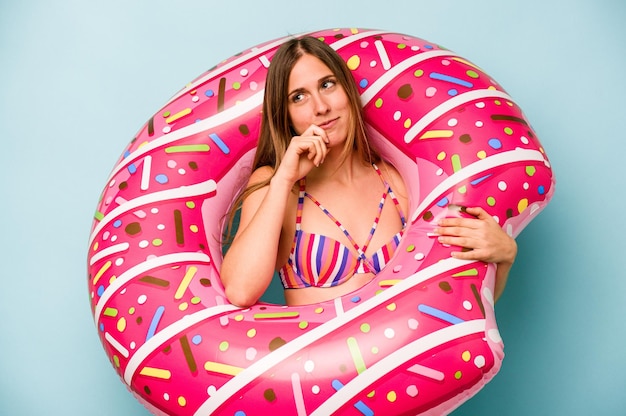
[{"xmin": 0, "ymin": 0, "xmax": 626, "ymax": 416}]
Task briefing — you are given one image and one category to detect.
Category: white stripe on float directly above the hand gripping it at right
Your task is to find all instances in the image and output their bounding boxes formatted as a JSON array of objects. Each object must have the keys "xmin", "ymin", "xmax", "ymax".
[{"xmin": 411, "ymin": 148, "xmax": 545, "ymax": 223}]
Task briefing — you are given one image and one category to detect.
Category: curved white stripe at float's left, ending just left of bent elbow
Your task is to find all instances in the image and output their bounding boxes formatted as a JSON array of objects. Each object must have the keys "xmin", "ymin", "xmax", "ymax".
[{"xmin": 93, "ymin": 253, "xmax": 211, "ymax": 326}]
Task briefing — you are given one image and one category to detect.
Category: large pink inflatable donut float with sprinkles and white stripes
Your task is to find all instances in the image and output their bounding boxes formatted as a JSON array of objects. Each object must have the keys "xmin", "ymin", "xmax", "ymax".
[{"xmin": 88, "ymin": 29, "xmax": 554, "ymax": 416}]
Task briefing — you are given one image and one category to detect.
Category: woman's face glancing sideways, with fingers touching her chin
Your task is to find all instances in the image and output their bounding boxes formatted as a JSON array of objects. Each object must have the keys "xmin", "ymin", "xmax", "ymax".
[{"xmin": 287, "ymin": 54, "xmax": 351, "ymax": 147}]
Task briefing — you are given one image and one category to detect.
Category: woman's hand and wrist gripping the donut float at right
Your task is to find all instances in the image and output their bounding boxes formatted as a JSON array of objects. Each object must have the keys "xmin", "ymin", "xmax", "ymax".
[{"xmin": 435, "ymin": 207, "xmax": 517, "ymax": 300}]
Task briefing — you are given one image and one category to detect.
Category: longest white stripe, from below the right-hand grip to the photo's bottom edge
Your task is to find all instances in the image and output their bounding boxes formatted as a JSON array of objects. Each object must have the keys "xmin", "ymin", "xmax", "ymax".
[{"xmin": 194, "ymin": 258, "xmax": 474, "ymax": 416}]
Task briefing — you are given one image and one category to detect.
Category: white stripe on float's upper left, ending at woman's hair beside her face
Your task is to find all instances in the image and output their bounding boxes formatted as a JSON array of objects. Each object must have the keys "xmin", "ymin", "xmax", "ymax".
[{"xmin": 107, "ymin": 90, "xmax": 263, "ymax": 183}]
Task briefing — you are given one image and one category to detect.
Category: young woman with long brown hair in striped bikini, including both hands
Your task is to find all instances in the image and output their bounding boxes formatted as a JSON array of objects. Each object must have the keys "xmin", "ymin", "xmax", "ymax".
[{"xmin": 221, "ymin": 37, "xmax": 517, "ymax": 307}]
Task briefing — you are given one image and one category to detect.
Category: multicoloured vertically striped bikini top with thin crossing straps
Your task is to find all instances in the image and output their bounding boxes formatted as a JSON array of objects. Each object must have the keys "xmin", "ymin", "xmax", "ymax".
[{"xmin": 278, "ymin": 165, "xmax": 406, "ymax": 289}]
